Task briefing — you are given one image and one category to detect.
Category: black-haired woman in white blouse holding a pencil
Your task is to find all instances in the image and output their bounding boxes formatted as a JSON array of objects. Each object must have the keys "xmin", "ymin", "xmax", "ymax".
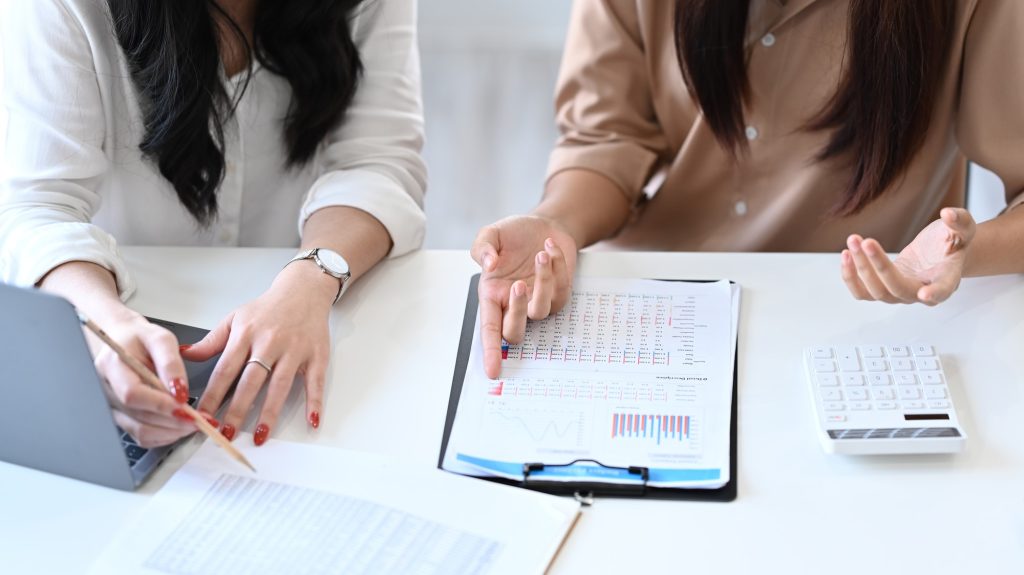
[{"xmin": 0, "ymin": 0, "xmax": 426, "ymax": 446}]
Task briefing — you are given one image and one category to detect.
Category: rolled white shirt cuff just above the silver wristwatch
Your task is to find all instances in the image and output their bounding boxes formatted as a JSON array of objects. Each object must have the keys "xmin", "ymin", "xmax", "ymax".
[{"xmin": 299, "ymin": 169, "xmax": 427, "ymax": 258}]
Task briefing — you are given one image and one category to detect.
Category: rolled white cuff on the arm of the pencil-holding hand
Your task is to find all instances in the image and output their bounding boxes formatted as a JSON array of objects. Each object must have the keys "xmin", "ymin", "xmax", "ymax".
[{"xmin": 0, "ymin": 222, "xmax": 135, "ymax": 301}]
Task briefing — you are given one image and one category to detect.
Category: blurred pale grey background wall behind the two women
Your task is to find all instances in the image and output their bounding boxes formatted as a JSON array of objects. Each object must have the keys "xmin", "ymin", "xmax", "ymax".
[{"xmin": 0, "ymin": 0, "xmax": 1005, "ymax": 250}]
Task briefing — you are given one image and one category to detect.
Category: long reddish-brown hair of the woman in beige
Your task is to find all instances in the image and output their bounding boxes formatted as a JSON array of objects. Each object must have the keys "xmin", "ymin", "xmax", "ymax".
[{"xmin": 675, "ymin": 0, "xmax": 954, "ymax": 215}]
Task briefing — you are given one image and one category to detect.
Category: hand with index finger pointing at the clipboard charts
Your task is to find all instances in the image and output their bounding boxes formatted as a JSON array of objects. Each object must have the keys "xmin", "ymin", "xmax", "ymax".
[{"xmin": 470, "ymin": 216, "xmax": 577, "ymax": 379}]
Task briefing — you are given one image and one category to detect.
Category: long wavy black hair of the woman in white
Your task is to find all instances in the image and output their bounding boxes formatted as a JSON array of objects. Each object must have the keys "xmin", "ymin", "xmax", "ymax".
[{"xmin": 108, "ymin": 0, "xmax": 362, "ymax": 225}]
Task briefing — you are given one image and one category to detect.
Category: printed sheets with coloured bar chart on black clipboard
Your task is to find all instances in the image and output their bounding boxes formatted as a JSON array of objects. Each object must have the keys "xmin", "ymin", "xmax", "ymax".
[{"xmin": 442, "ymin": 277, "xmax": 739, "ymax": 488}]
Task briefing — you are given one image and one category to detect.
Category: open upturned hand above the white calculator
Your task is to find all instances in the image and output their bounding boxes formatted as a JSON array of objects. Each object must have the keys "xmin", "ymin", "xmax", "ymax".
[{"xmin": 842, "ymin": 208, "xmax": 977, "ymax": 306}]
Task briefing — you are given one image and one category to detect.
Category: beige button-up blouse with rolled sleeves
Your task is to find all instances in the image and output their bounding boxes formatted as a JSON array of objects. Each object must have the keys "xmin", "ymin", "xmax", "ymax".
[{"xmin": 548, "ymin": 0, "xmax": 1024, "ymax": 252}]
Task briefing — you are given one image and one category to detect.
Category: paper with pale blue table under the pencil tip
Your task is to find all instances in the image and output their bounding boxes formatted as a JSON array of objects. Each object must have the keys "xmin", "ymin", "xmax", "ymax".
[{"xmin": 92, "ymin": 437, "xmax": 580, "ymax": 575}]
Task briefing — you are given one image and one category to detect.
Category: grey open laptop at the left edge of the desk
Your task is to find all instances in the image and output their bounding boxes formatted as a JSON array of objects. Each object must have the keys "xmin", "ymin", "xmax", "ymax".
[{"xmin": 0, "ymin": 283, "xmax": 218, "ymax": 490}]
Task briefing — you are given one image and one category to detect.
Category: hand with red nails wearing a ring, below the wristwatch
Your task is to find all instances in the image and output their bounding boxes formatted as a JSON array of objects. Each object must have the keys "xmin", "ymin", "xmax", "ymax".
[{"xmin": 182, "ymin": 261, "xmax": 329, "ymax": 445}]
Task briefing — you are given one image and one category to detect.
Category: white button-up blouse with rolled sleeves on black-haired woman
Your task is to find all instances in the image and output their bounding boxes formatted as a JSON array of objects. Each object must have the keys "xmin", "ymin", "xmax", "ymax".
[{"xmin": 0, "ymin": 0, "xmax": 427, "ymax": 298}]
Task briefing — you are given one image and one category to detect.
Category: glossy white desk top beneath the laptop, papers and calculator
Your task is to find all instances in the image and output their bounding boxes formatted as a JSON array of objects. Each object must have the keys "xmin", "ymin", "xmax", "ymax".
[{"xmin": 0, "ymin": 249, "xmax": 1024, "ymax": 575}]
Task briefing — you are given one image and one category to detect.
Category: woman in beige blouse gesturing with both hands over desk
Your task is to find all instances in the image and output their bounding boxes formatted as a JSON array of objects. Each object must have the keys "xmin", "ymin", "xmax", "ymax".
[{"xmin": 472, "ymin": 0, "xmax": 1024, "ymax": 377}]
